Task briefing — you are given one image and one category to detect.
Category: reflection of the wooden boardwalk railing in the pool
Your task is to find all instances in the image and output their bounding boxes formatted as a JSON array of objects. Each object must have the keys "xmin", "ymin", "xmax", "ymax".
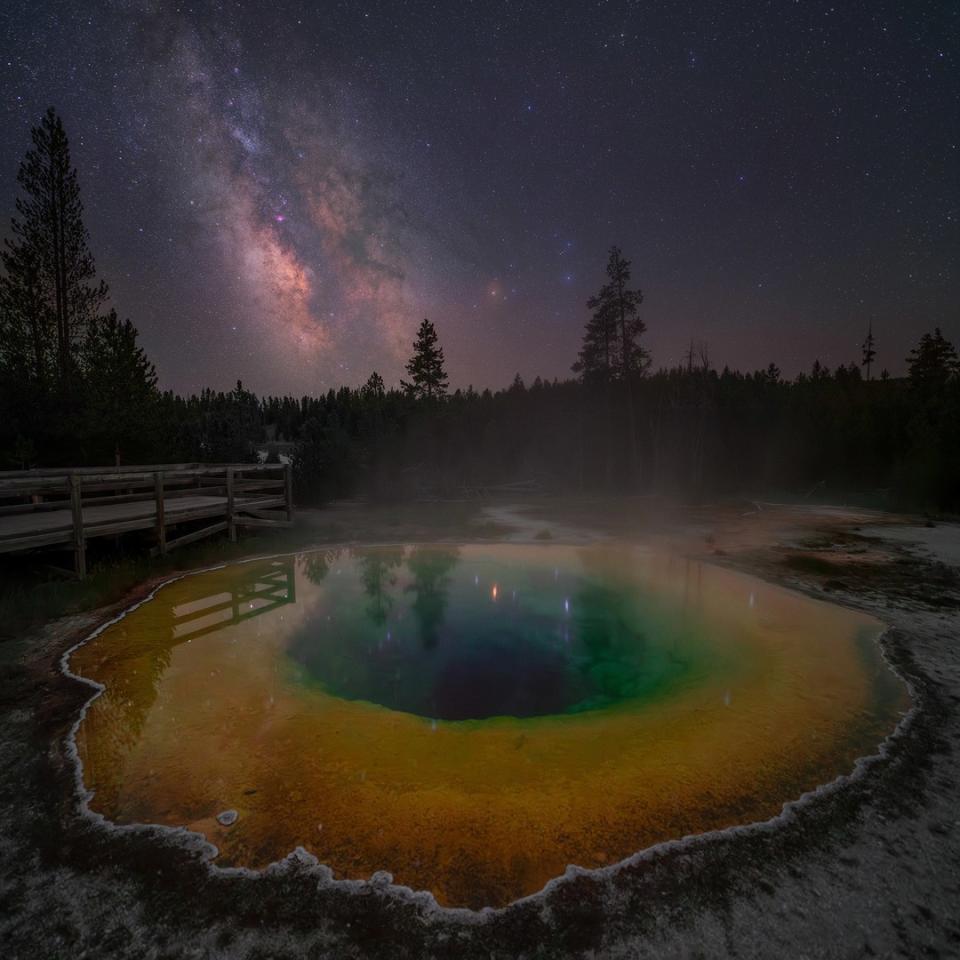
[{"xmin": 170, "ymin": 557, "xmax": 297, "ymax": 644}]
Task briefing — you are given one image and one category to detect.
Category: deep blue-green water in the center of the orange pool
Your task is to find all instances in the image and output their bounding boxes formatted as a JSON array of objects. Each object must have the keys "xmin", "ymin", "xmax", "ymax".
[{"xmin": 288, "ymin": 547, "xmax": 707, "ymax": 720}]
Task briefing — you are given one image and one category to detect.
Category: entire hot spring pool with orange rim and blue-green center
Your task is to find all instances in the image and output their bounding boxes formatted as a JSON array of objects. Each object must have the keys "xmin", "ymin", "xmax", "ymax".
[{"xmin": 69, "ymin": 545, "xmax": 907, "ymax": 908}]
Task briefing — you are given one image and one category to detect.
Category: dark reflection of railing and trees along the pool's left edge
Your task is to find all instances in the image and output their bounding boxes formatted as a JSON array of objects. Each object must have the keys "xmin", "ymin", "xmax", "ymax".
[{"xmin": 74, "ymin": 558, "xmax": 296, "ymax": 810}]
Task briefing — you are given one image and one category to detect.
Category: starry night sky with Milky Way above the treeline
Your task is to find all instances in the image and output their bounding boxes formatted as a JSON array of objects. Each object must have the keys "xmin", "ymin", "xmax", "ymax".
[{"xmin": 0, "ymin": 0, "xmax": 960, "ymax": 394}]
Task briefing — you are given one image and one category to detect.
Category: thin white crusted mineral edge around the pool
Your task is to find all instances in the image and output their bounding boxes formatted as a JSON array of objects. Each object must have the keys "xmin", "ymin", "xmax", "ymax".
[{"xmin": 60, "ymin": 541, "xmax": 920, "ymax": 924}]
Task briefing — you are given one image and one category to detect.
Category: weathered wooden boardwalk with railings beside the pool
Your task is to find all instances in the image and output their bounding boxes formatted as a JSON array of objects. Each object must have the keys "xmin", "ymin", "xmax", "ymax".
[{"xmin": 0, "ymin": 463, "xmax": 293, "ymax": 577}]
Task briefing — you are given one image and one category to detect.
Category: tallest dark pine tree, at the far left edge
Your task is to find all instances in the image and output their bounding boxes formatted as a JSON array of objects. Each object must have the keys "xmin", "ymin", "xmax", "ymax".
[{"xmin": 0, "ymin": 107, "xmax": 108, "ymax": 390}]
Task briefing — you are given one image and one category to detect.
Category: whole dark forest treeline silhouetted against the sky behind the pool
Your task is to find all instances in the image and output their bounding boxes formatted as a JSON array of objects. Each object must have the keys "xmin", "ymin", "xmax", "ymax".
[{"xmin": 0, "ymin": 110, "xmax": 960, "ymax": 510}]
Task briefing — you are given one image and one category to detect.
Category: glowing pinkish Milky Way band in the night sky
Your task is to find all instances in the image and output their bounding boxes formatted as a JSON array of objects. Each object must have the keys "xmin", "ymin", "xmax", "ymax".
[{"xmin": 142, "ymin": 7, "xmax": 442, "ymax": 389}]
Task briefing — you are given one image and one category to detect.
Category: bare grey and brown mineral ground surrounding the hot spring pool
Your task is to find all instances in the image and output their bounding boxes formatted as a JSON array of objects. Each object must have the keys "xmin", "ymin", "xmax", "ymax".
[{"xmin": 0, "ymin": 500, "xmax": 960, "ymax": 960}]
